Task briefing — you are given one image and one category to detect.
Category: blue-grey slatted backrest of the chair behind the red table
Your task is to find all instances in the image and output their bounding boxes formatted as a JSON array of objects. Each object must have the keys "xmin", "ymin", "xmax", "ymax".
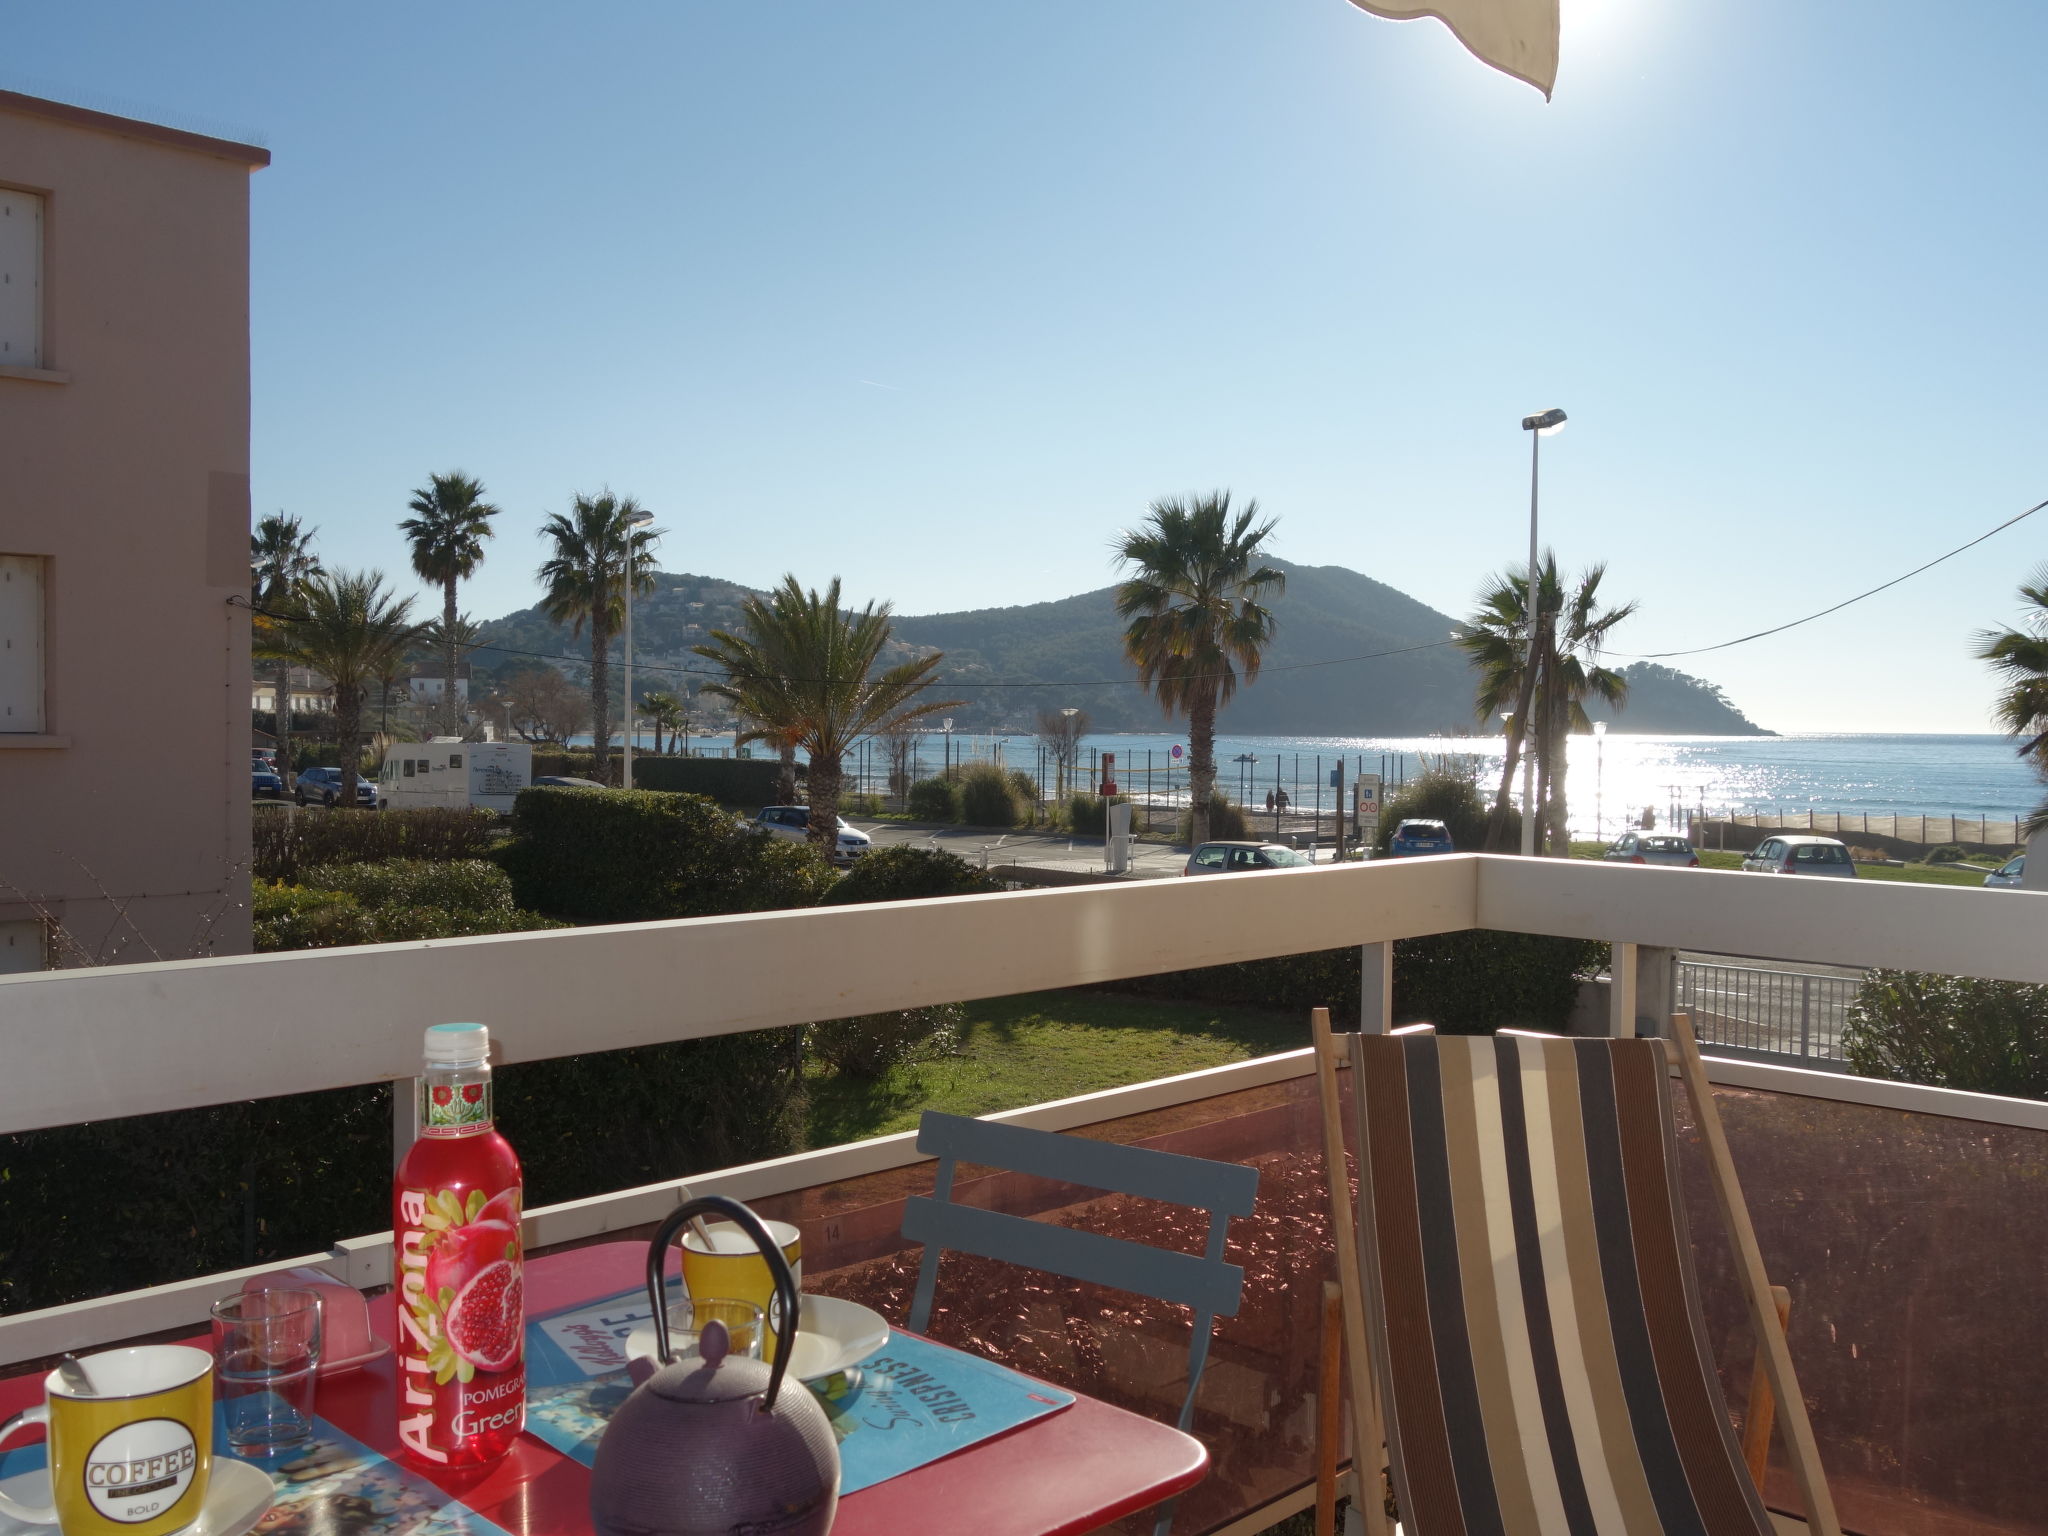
[{"xmin": 903, "ymin": 1110, "xmax": 1260, "ymax": 1430}]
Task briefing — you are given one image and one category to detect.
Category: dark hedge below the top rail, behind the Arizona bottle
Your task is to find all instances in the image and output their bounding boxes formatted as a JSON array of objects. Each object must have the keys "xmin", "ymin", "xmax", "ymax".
[{"xmin": 0, "ymin": 1028, "xmax": 803, "ymax": 1313}]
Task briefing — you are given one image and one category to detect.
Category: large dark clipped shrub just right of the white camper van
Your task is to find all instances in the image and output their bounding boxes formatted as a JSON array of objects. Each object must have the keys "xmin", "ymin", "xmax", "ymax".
[{"xmin": 498, "ymin": 788, "xmax": 831, "ymax": 924}]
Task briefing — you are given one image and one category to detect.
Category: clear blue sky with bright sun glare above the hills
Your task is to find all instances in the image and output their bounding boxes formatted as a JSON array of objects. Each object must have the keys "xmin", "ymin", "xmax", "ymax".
[{"xmin": 16, "ymin": 0, "xmax": 2048, "ymax": 731}]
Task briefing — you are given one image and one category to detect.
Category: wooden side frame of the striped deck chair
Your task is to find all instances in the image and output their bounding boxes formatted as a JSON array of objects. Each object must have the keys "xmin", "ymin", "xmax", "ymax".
[{"xmin": 1311, "ymin": 1008, "xmax": 1841, "ymax": 1536}]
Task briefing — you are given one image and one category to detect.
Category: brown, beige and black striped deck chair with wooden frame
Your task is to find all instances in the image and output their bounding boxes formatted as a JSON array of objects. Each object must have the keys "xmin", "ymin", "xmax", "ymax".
[{"xmin": 1317, "ymin": 1016, "xmax": 1841, "ymax": 1536}]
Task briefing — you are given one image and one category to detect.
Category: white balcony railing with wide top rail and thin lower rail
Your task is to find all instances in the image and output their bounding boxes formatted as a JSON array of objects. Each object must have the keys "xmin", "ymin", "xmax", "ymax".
[{"xmin": 0, "ymin": 854, "xmax": 2048, "ymax": 1360}]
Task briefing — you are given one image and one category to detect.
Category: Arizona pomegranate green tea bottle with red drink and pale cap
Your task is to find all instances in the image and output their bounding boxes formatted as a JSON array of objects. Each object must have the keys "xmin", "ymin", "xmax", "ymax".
[{"xmin": 391, "ymin": 1024, "xmax": 526, "ymax": 1468}]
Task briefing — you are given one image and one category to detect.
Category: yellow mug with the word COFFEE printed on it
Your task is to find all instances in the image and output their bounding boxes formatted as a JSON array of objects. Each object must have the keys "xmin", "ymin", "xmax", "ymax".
[{"xmin": 0, "ymin": 1343, "xmax": 213, "ymax": 1536}]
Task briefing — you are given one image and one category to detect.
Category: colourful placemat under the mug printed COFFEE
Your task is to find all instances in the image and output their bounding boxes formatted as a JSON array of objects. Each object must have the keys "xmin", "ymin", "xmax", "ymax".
[{"xmin": 0, "ymin": 1411, "xmax": 508, "ymax": 1536}]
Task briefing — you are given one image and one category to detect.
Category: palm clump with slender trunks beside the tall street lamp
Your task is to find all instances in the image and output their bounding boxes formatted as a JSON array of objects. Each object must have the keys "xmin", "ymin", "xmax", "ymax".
[{"xmin": 1458, "ymin": 551, "xmax": 1636, "ymax": 858}]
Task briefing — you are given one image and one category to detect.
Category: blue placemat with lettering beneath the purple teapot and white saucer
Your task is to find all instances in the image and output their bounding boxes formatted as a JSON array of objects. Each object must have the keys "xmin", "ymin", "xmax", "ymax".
[{"xmin": 526, "ymin": 1290, "xmax": 1073, "ymax": 1493}]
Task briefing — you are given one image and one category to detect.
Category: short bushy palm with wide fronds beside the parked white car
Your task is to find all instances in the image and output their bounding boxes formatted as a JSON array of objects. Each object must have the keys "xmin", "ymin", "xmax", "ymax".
[{"xmin": 692, "ymin": 575, "xmax": 961, "ymax": 858}]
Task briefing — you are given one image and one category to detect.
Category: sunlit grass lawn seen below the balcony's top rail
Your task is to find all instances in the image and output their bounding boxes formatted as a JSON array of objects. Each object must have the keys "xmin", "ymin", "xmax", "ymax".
[{"xmin": 809, "ymin": 991, "xmax": 1309, "ymax": 1147}]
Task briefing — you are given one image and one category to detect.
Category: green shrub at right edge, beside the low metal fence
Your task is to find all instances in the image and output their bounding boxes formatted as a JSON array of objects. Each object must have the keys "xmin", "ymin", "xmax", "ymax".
[{"xmin": 1841, "ymin": 971, "xmax": 2048, "ymax": 1098}]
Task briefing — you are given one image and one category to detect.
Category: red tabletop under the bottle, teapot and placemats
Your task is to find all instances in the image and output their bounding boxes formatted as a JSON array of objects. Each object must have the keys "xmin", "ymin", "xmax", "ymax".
[{"xmin": 0, "ymin": 1243, "xmax": 1208, "ymax": 1536}]
